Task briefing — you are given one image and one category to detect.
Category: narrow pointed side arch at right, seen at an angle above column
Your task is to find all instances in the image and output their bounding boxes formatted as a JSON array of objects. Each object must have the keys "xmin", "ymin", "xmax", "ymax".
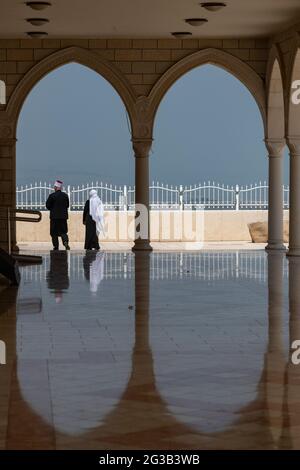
[{"xmin": 266, "ymin": 46, "xmax": 285, "ymax": 139}]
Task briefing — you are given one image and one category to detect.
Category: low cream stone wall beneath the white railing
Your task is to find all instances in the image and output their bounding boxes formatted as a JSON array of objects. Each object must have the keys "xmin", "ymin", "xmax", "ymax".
[{"xmin": 17, "ymin": 210, "xmax": 288, "ymax": 243}]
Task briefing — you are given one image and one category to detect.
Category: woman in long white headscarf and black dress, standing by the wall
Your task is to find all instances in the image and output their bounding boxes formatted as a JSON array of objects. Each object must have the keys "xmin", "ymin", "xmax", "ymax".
[{"xmin": 83, "ymin": 189, "xmax": 104, "ymax": 250}]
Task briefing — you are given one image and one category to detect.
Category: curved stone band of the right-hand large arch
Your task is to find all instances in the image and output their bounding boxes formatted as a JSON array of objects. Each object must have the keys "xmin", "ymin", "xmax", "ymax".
[{"xmin": 149, "ymin": 48, "xmax": 266, "ymax": 134}]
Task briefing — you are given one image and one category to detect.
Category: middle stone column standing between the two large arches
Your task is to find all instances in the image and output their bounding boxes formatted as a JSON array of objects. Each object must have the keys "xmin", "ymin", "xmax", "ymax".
[{"xmin": 132, "ymin": 138, "xmax": 152, "ymax": 251}]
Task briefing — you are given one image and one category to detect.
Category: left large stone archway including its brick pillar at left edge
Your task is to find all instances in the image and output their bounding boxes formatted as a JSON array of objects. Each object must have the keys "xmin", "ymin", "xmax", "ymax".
[{"xmin": 0, "ymin": 47, "xmax": 144, "ymax": 252}]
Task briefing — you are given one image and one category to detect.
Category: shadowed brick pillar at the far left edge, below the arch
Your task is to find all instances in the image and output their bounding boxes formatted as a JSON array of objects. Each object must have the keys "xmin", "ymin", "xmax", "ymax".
[{"xmin": 0, "ymin": 123, "xmax": 16, "ymax": 249}]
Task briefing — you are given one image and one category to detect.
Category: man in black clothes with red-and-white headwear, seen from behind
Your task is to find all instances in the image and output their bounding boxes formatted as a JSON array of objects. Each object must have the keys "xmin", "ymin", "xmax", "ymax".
[{"xmin": 46, "ymin": 180, "xmax": 70, "ymax": 250}]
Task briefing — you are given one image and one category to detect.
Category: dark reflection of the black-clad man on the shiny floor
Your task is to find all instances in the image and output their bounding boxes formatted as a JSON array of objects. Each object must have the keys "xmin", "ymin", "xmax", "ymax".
[{"xmin": 47, "ymin": 251, "xmax": 70, "ymax": 303}]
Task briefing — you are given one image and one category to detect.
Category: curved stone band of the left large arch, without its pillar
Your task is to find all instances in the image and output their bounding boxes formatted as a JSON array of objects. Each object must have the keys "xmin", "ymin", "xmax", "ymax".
[{"xmin": 7, "ymin": 46, "xmax": 135, "ymax": 134}]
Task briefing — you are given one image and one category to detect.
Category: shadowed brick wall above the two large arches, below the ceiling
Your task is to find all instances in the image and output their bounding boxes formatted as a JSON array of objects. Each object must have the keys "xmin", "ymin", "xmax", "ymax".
[{"xmin": 0, "ymin": 38, "xmax": 269, "ymax": 103}]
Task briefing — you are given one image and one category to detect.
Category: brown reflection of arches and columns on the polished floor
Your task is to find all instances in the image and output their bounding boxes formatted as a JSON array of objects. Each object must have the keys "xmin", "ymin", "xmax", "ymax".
[{"xmin": 3, "ymin": 253, "xmax": 292, "ymax": 450}]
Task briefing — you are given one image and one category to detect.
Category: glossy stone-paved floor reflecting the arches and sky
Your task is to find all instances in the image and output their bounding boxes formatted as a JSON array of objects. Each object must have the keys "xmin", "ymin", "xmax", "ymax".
[{"xmin": 0, "ymin": 250, "xmax": 300, "ymax": 450}]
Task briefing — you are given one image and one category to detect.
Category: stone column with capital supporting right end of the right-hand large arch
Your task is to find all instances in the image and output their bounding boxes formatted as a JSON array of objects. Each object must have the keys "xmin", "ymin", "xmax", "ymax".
[{"xmin": 265, "ymin": 139, "xmax": 285, "ymax": 251}]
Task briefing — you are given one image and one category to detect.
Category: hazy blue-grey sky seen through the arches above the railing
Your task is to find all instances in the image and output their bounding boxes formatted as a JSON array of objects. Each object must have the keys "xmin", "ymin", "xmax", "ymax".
[{"xmin": 17, "ymin": 64, "xmax": 288, "ymax": 185}]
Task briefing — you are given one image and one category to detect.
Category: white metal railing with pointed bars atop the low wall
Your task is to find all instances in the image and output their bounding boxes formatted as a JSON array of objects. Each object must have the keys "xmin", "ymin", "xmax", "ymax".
[{"xmin": 16, "ymin": 181, "xmax": 289, "ymax": 210}]
